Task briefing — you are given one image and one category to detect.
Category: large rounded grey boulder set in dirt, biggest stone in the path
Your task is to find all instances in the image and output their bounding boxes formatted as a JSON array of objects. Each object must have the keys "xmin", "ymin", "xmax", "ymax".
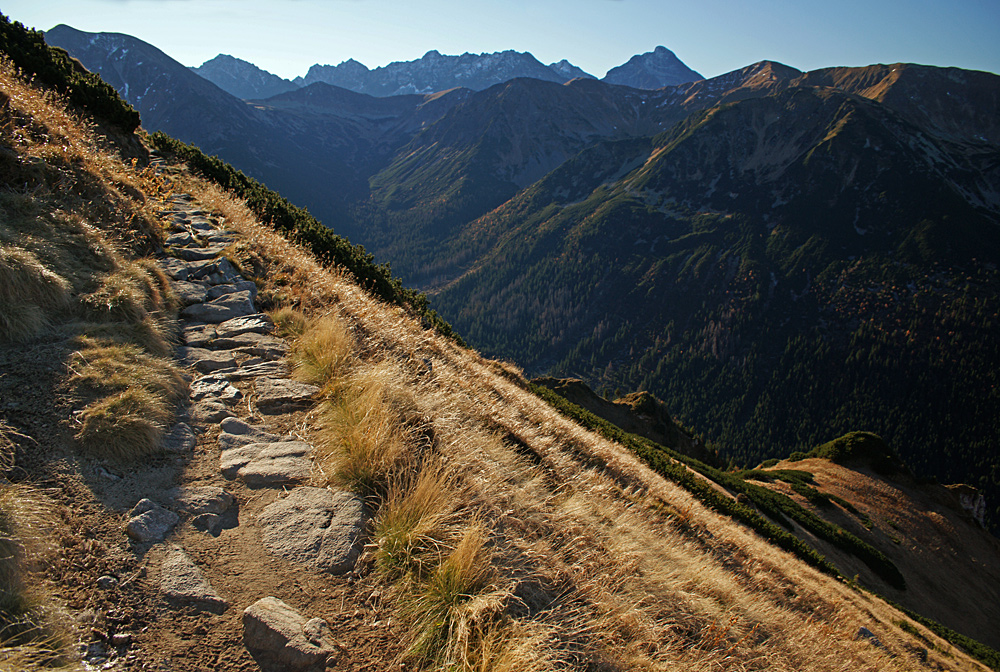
[{"xmin": 257, "ymin": 486, "xmax": 367, "ymax": 574}]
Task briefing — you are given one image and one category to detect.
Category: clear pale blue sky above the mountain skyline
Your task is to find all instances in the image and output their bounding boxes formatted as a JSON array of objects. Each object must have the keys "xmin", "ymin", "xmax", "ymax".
[{"xmin": 0, "ymin": 0, "xmax": 1000, "ymax": 78}]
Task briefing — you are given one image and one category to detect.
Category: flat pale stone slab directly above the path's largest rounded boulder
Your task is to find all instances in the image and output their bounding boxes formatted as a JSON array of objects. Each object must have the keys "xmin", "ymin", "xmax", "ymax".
[{"xmin": 219, "ymin": 441, "xmax": 312, "ymax": 487}]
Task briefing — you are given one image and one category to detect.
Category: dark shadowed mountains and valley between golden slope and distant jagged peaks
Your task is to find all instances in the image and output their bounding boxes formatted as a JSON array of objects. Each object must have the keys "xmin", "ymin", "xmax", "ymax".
[{"xmin": 46, "ymin": 26, "xmax": 1000, "ymax": 532}]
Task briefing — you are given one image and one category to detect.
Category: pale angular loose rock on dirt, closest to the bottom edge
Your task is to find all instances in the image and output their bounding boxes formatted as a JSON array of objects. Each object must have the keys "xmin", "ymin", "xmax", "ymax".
[{"xmin": 243, "ymin": 597, "xmax": 336, "ymax": 672}]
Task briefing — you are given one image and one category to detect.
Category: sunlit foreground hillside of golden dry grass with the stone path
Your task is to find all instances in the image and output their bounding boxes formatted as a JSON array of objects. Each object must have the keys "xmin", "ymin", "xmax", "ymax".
[{"xmin": 0, "ymin": 14, "xmax": 1000, "ymax": 670}]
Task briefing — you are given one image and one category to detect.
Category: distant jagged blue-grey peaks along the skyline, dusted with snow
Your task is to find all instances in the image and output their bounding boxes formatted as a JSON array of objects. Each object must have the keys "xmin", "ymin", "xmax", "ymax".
[{"xmin": 189, "ymin": 45, "xmax": 703, "ymax": 100}]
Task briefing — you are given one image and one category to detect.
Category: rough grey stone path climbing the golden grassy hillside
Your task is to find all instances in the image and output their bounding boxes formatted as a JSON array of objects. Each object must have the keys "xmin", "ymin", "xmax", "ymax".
[{"xmin": 116, "ymin": 195, "xmax": 369, "ymax": 669}]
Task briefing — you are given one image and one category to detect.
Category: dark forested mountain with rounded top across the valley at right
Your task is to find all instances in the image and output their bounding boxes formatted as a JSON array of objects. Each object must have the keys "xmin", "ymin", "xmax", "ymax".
[{"xmin": 435, "ymin": 88, "xmax": 1000, "ymax": 520}]
